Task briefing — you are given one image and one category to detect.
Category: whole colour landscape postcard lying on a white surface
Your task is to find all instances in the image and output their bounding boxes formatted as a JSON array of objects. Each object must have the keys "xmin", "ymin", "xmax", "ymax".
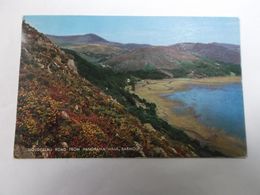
[{"xmin": 14, "ymin": 16, "xmax": 247, "ymax": 159}]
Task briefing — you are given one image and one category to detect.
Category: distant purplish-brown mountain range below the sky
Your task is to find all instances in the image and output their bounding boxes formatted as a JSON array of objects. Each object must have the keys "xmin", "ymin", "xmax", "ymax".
[{"xmin": 47, "ymin": 34, "xmax": 240, "ymax": 71}]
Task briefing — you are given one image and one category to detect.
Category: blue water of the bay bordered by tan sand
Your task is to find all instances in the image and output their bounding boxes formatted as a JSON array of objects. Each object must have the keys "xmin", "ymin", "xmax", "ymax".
[{"xmin": 167, "ymin": 84, "xmax": 245, "ymax": 139}]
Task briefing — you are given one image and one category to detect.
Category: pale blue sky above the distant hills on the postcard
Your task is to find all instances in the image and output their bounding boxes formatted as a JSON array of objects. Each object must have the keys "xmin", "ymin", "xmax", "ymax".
[{"xmin": 24, "ymin": 16, "xmax": 240, "ymax": 45}]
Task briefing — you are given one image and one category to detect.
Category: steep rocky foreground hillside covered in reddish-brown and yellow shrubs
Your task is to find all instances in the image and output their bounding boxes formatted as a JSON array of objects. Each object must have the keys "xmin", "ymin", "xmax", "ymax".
[{"xmin": 14, "ymin": 23, "xmax": 206, "ymax": 158}]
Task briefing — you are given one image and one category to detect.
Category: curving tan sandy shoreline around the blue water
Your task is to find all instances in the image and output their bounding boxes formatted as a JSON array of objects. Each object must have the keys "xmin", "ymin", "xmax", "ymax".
[{"xmin": 133, "ymin": 77, "xmax": 246, "ymax": 156}]
